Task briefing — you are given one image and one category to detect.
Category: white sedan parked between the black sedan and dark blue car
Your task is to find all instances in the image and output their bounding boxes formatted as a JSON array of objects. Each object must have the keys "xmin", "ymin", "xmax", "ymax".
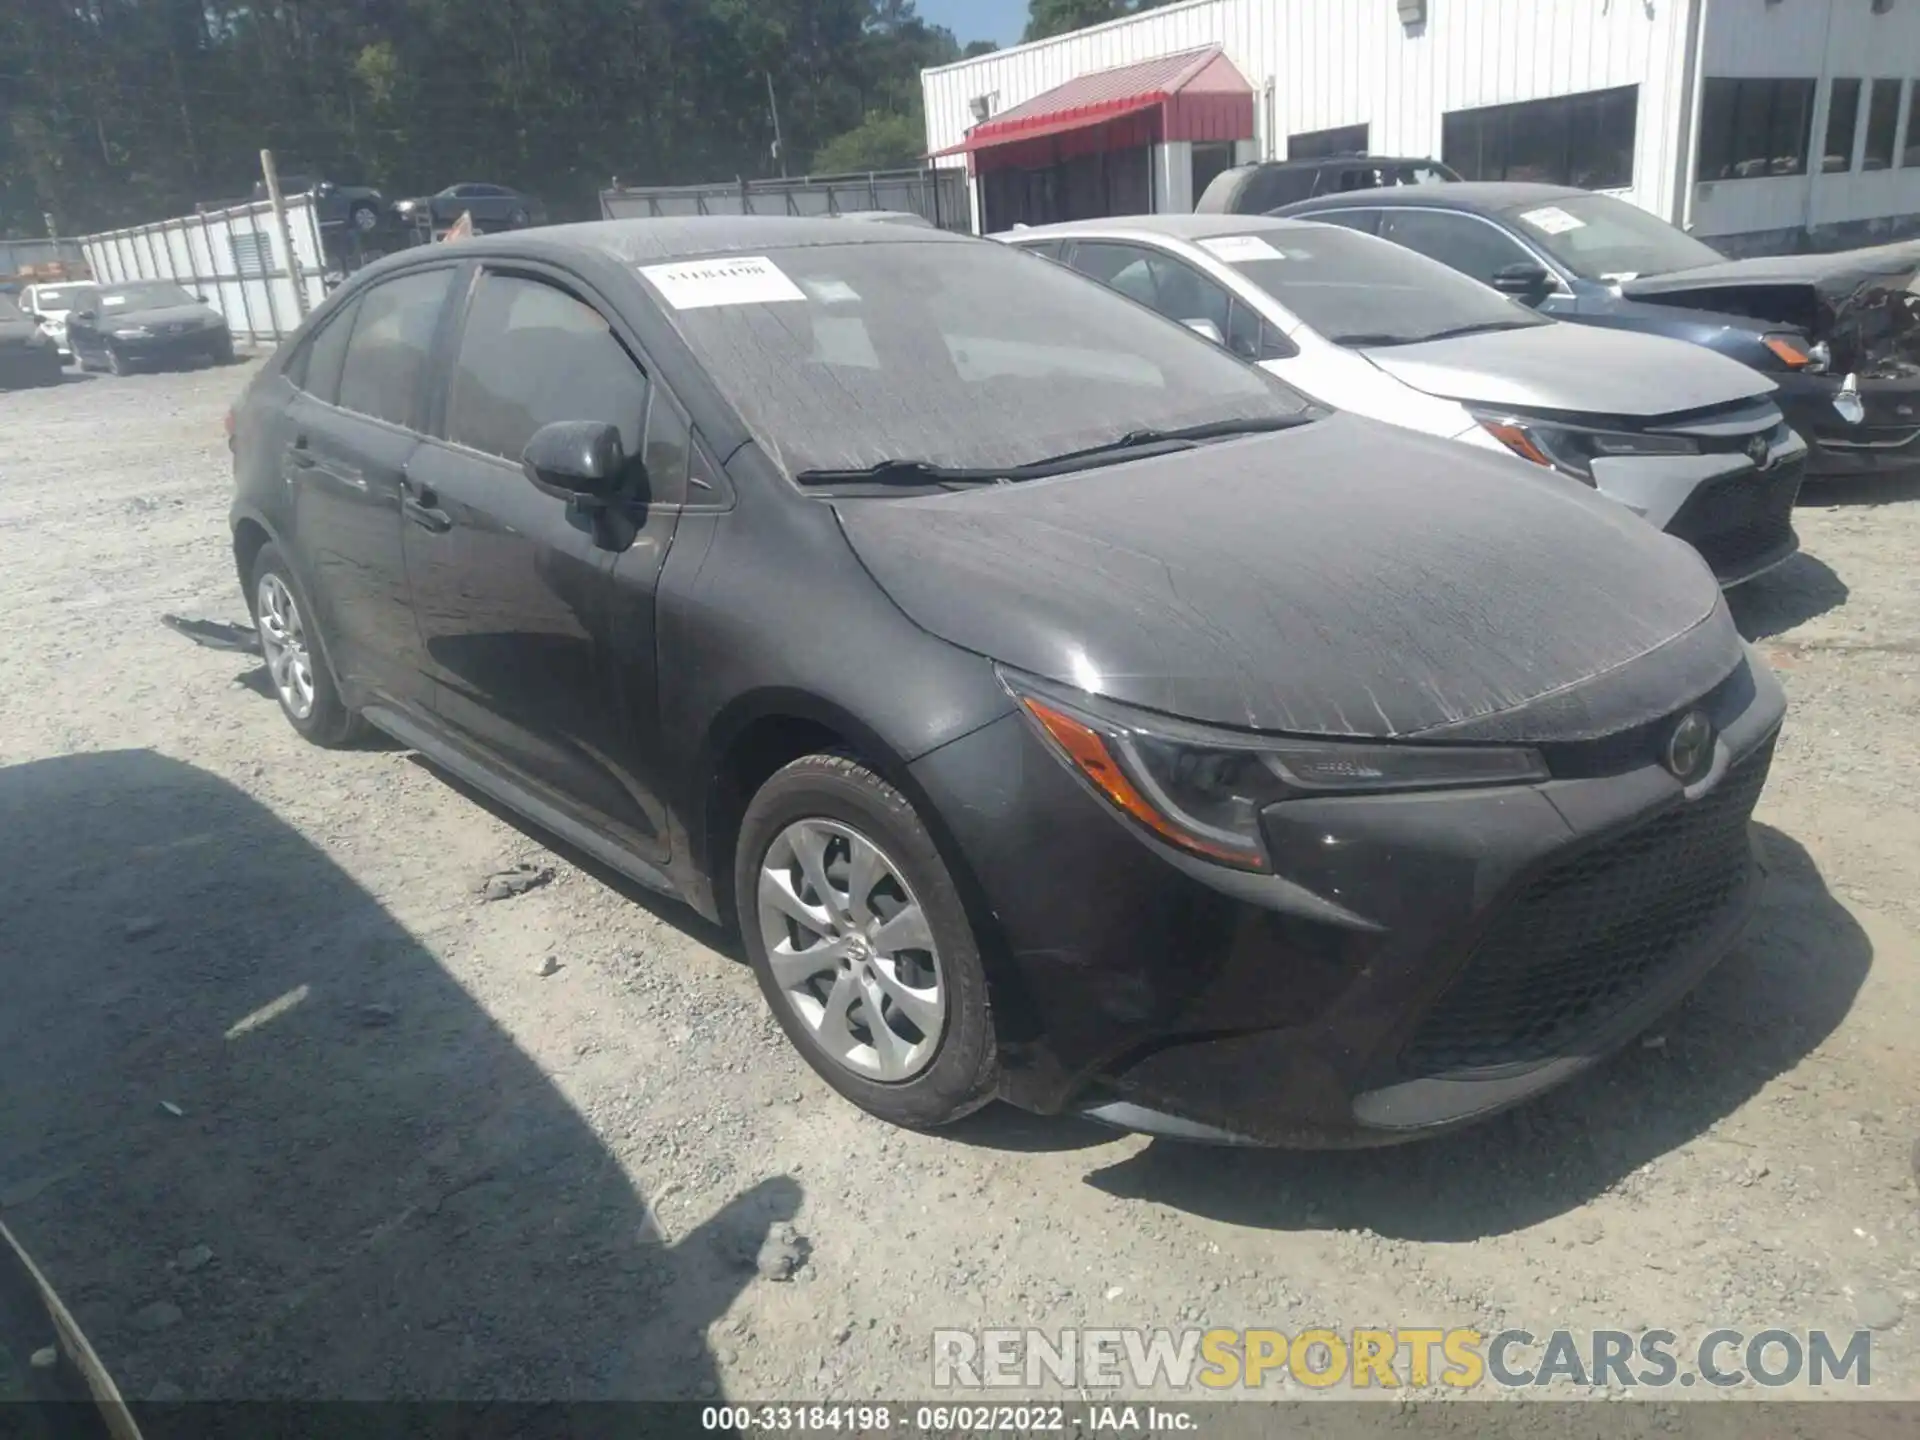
[{"xmin": 1004, "ymin": 215, "xmax": 1807, "ymax": 586}]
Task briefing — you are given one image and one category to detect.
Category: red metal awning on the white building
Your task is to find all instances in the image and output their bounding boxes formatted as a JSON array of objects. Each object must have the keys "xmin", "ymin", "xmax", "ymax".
[{"xmin": 935, "ymin": 46, "xmax": 1254, "ymax": 156}]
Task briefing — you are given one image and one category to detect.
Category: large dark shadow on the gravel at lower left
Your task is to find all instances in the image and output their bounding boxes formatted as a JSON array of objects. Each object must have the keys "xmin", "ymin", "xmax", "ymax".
[{"xmin": 0, "ymin": 751, "xmax": 801, "ymax": 1405}]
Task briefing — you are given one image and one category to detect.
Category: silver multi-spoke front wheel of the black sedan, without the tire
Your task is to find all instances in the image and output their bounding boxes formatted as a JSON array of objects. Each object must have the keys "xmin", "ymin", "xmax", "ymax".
[{"xmin": 758, "ymin": 820, "xmax": 947, "ymax": 1083}]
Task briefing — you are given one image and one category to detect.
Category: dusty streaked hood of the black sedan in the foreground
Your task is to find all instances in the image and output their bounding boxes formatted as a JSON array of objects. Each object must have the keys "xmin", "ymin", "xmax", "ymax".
[{"xmin": 835, "ymin": 415, "xmax": 1743, "ymax": 741}]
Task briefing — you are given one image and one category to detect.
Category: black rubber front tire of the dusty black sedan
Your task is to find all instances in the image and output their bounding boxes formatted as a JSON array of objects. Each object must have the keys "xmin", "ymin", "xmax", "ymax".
[{"xmin": 733, "ymin": 755, "xmax": 998, "ymax": 1129}]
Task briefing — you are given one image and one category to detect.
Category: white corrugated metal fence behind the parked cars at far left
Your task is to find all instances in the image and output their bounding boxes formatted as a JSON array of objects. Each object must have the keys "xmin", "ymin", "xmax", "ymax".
[{"xmin": 79, "ymin": 196, "xmax": 326, "ymax": 342}]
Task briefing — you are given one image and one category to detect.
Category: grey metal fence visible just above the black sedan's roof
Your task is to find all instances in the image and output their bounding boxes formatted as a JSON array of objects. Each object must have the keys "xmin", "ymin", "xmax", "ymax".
[{"xmin": 601, "ymin": 167, "xmax": 972, "ymax": 230}]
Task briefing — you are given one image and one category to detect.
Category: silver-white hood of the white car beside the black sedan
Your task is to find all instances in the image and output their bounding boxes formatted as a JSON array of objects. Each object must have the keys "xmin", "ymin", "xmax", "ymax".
[{"xmin": 1361, "ymin": 324, "xmax": 1774, "ymax": 419}]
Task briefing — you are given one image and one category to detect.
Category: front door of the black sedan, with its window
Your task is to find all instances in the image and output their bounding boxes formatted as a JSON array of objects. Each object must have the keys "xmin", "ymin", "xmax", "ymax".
[{"xmin": 403, "ymin": 269, "xmax": 684, "ymax": 860}]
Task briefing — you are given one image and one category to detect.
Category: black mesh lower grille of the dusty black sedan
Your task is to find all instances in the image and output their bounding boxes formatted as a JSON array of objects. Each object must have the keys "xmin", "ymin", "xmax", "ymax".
[{"xmin": 1402, "ymin": 743, "xmax": 1772, "ymax": 1075}]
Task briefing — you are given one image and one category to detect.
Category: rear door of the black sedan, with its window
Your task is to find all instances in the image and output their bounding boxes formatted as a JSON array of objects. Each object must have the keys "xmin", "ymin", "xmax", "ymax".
[{"xmin": 282, "ymin": 265, "xmax": 459, "ymax": 712}]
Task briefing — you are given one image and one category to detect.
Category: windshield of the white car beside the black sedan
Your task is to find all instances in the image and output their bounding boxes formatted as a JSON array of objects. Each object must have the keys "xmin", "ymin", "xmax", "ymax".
[{"xmin": 1221, "ymin": 225, "xmax": 1551, "ymax": 346}]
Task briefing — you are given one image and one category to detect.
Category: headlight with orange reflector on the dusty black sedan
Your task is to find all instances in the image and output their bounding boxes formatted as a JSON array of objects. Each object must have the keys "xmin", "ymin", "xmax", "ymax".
[{"xmin": 1000, "ymin": 668, "xmax": 1548, "ymax": 870}]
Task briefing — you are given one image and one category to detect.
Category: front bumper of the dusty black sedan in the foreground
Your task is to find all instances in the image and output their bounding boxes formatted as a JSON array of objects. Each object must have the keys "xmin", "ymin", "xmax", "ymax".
[{"xmin": 914, "ymin": 655, "xmax": 1786, "ymax": 1146}]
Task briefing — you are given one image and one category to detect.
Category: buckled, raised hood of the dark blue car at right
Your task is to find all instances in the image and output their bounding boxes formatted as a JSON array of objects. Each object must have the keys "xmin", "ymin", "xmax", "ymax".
[{"xmin": 1620, "ymin": 240, "xmax": 1920, "ymax": 380}]
